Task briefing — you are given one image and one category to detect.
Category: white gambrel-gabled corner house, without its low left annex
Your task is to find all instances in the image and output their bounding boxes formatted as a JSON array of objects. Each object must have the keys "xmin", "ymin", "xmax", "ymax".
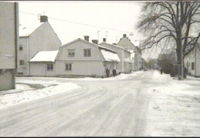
[{"xmin": 55, "ymin": 36, "xmax": 120, "ymax": 77}]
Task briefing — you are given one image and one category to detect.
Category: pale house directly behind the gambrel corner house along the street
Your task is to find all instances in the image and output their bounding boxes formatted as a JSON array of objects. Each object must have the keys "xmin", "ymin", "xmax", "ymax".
[{"xmin": 100, "ymin": 38, "xmax": 134, "ymax": 73}]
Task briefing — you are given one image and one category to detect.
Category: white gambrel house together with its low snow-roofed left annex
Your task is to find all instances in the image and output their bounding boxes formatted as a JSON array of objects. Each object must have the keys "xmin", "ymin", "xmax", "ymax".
[{"xmin": 30, "ymin": 37, "xmax": 120, "ymax": 77}]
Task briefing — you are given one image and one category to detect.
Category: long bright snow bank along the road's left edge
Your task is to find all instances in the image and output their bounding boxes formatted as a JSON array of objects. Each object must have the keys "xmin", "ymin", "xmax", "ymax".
[{"xmin": 0, "ymin": 82, "xmax": 80, "ymax": 109}]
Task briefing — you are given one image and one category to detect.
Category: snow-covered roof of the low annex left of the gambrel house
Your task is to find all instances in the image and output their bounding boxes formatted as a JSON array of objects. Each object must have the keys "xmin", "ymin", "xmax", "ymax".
[{"xmin": 30, "ymin": 50, "xmax": 58, "ymax": 62}]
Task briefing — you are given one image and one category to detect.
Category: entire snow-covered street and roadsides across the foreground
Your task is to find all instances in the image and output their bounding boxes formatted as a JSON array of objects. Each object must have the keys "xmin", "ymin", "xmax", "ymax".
[{"xmin": 0, "ymin": 71, "xmax": 200, "ymax": 136}]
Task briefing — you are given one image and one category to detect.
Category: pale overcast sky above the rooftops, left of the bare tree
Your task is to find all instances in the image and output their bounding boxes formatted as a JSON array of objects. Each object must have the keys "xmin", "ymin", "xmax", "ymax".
[{"xmin": 19, "ymin": 1, "xmax": 158, "ymax": 58}]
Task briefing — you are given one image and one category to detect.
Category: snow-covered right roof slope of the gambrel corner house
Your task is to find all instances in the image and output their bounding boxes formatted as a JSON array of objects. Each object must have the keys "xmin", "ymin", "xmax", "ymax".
[{"xmin": 100, "ymin": 49, "xmax": 120, "ymax": 62}]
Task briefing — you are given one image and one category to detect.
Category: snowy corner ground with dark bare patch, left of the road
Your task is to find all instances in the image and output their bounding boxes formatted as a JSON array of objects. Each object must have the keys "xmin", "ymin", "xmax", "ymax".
[{"xmin": 0, "ymin": 80, "xmax": 80, "ymax": 109}]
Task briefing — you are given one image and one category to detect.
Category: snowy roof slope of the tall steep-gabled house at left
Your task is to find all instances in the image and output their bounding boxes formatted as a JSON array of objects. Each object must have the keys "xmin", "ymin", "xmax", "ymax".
[{"xmin": 19, "ymin": 22, "xmax": 43, "ymax": 37}]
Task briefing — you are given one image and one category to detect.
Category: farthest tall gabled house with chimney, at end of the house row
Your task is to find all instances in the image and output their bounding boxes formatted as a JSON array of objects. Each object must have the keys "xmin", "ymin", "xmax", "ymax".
[{"xmin": 117, "ymin": 34, "xmax": 143, "ymax": 71}]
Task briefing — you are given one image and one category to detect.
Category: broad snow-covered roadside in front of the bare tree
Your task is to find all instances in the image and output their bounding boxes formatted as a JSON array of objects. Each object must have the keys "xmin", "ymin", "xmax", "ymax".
[{"xmin": 146, "ymin": 72, "xmax": 200, "ymax": 136}]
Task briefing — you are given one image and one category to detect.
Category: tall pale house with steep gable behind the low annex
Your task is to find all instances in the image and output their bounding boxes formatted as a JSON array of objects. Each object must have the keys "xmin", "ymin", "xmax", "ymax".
[{"xmin": 17, "ymin": 16, "xmax": 61, "ymax": 76}]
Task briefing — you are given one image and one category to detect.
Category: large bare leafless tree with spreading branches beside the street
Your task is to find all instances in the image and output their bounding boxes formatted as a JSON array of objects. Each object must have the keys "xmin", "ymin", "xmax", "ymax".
[{"xmin": 138, "ymin": 1, "xmax": 200, "ymax": 79}]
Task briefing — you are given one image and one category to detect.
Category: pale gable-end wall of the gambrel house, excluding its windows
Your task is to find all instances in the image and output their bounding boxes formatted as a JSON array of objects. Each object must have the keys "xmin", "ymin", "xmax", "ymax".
[{"xmin": 56, "ymin": 40, "xmax": 105, "ymax": 76}]
